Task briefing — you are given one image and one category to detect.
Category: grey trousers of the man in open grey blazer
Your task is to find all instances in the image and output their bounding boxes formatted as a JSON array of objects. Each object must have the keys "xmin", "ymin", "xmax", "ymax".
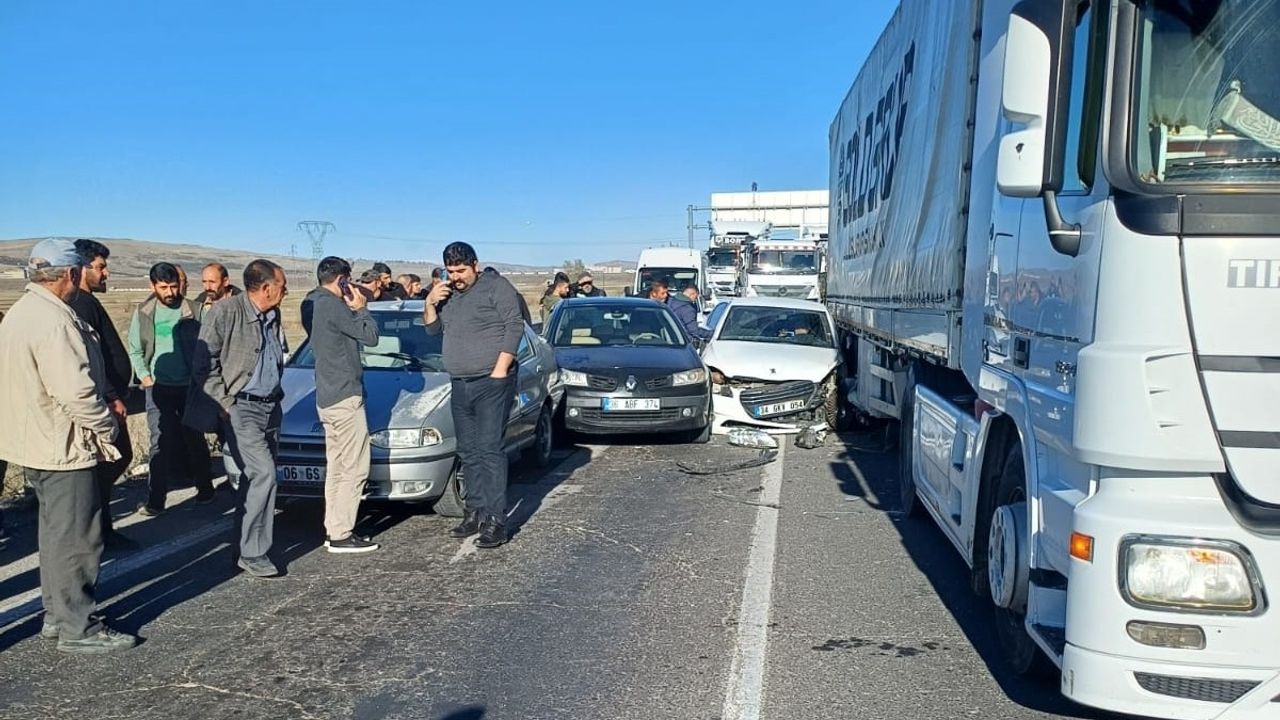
[{"xmin": 227, "ymin": 400, "xmax": 280, "ymax": 557}]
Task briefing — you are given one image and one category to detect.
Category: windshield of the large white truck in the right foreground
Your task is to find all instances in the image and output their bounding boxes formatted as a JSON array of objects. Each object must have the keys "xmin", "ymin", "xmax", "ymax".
[{"xmin": 1130, "ymin": 0, "xmax": 1280, "ymax": 184}]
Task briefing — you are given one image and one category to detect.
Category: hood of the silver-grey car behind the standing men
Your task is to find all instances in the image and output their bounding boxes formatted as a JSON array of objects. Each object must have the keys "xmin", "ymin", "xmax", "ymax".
[{"xmin": 280, "ymin": 368, "xmax": 449, "ymax": 437}]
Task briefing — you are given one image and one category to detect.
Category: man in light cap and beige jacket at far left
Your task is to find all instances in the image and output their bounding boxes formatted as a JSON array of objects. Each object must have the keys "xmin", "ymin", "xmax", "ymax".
[{"xmin": 0, "ymin": 238, "xmax": 137, "ymax": 653}]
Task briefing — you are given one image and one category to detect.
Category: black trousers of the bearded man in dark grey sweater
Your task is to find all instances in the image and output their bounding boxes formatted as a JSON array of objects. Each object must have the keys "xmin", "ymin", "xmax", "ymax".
[{"xmin": 451, "ymin": 374, "xmax": 516, "ymax": 523}]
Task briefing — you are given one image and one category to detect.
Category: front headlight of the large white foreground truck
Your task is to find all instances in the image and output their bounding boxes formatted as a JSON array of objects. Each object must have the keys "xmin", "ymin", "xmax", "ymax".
[{"xmin": 1121, "ymin": 537, "xmax": 1258, "ymax": 612}]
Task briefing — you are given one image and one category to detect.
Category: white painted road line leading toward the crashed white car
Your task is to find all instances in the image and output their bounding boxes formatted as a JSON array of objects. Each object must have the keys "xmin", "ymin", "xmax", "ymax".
[{"xmin": 721, "ymin": 445, "xmax": 786, "ymax": 720}]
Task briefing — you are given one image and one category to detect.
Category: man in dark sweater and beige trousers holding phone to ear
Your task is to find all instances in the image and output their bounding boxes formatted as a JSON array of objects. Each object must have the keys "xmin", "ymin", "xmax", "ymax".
[{"xmin": 302, "ymin": 256, "xmax": 378, "ymax": 553}]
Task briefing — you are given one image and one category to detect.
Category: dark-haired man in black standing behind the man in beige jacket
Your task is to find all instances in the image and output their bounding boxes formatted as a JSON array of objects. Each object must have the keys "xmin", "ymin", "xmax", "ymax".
[{"xmin": 69, "ymin": 238, "xmax": 137, "ymax": 550}]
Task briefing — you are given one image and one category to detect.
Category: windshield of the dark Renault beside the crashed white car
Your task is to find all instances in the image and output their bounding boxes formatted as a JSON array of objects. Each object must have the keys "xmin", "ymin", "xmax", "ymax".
[{"xmin": 552, "ymin": 302, "xmax": 686, "ymax": 347}]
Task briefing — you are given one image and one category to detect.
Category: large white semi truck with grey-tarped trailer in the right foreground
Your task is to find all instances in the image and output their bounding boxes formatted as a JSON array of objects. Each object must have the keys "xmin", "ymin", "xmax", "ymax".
[{"xmin": 826, "ymin": 0, "xmax": 1280, "ymax": 720}]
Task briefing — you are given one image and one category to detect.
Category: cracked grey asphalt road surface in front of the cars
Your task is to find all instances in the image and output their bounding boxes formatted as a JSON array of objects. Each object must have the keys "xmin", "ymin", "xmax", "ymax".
[{"xmin": 0, "ymin": 433, "xmax": 1121, "ymax": 720}]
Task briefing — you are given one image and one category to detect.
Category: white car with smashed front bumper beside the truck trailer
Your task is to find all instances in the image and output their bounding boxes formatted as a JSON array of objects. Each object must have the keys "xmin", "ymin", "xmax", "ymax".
[{"xmin": 703, "ymin": 297, "xmax": 840, "ymax": 433}]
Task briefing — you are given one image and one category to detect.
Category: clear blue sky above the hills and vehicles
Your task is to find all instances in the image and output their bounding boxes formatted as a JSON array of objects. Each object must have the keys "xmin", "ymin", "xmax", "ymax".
[{"xmin": 0, "ymin": 0, "xmax": 895, "ymax": 264}]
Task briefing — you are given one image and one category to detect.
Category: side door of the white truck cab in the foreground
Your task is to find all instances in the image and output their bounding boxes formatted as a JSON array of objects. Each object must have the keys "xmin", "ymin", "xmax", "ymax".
[{"xmin": 1009, "ymin": 0, "xmax": 1108, "ymax": 575}]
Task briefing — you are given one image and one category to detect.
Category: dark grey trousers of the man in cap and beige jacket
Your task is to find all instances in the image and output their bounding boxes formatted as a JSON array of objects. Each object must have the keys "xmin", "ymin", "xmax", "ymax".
[{"xmin": 26, "ymin": 468, "xmax": 102, "ymax": 641}]
